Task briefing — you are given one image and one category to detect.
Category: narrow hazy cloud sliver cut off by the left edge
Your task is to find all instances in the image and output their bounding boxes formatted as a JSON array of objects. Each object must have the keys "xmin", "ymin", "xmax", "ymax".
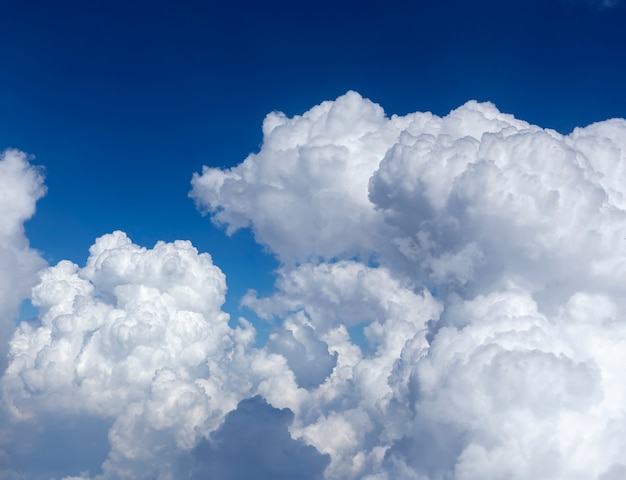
[{"xmin": 0, "ymin": 150, "xmax": 46, "ymax": 372}]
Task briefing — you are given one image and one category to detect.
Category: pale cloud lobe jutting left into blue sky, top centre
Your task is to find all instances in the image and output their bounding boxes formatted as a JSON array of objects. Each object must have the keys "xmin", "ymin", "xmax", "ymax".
[{"xmin": 191, "ymin": 92, "xmax": 406, "ymax": 262}]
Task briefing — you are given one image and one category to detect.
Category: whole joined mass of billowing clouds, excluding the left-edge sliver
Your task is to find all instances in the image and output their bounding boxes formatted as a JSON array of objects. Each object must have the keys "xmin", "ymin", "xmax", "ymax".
[{"xmin": 6, "ymin": 92, "xmax": 626, "ymax": 480}]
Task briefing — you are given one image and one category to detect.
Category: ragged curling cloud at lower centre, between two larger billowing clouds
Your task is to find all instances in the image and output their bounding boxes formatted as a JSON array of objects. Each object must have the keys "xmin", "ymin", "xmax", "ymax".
[{"xmin": 244, "ymin": 261, "xmax": 440, "ymax": 478}]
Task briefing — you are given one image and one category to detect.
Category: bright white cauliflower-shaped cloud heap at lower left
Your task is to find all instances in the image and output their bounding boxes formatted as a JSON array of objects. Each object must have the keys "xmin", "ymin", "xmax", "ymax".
[{"xmin": 2, "ymin": 232, "xmax": 264, "ymax": 478}]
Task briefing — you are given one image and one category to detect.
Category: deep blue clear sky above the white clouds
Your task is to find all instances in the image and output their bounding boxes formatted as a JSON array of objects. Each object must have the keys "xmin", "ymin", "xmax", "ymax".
[{"xmin": 0, "ymin": 0, "xmax": 626, "ymax": 318}]
